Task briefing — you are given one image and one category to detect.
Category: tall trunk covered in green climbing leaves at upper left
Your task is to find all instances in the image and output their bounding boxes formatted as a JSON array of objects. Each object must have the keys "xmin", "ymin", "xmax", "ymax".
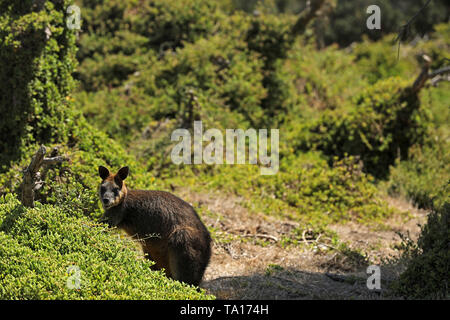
[{"xmin": 0, "ymin": 1, "xmax": 75, "ymax": 165}]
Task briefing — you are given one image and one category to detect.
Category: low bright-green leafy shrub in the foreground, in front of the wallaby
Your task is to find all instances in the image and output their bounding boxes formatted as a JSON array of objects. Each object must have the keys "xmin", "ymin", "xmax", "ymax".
[{"xmin": 0, "ymin": 195, "xmax": 213, "ymax": 300}]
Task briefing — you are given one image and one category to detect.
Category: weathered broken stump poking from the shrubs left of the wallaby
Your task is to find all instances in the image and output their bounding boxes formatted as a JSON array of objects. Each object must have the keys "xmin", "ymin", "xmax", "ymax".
[{"xmin": 21, "ymin": 145, "xmax": 68, "ymax": 208}]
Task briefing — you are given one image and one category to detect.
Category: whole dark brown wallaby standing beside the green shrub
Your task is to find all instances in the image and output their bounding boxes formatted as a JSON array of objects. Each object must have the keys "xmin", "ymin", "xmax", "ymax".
[{"xmin": 98, "ymin": 166, "xmax": 211, "ymax": 286}]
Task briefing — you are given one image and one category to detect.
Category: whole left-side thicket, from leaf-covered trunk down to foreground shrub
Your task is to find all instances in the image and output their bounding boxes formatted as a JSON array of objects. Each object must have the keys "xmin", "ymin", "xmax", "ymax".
[{"xmin": 0, "ymin": 1, "xmax": 211, "ymax": 299}]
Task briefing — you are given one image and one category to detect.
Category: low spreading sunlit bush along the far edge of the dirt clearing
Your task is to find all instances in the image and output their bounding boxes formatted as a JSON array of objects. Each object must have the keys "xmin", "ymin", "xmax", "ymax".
[{"xmin": 169, "ymin": 152, "xmax": 394, "ymax": 228}]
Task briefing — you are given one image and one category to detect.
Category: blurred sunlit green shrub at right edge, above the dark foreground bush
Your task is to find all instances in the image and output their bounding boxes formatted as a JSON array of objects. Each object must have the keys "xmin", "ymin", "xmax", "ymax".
[{"xmin": 387, "ymin": 83, "xmax": 450, "ymax": 209}]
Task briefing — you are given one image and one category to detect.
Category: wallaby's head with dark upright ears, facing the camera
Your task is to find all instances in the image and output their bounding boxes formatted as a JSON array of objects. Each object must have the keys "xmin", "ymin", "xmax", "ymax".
[{"xmin": 98, "ymin": 166, "xmax": 128, "ymax": 210}]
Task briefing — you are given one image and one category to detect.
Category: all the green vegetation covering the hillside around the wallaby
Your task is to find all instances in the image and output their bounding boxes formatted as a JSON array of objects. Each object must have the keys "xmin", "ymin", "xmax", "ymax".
[{"xmin": 0, "ymin": 0, "xmax": 450, "ymax": 299}]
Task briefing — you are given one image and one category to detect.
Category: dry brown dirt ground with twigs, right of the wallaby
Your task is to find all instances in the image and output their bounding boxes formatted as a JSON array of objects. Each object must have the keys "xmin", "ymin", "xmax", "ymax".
[{"xmin": 176, "ymin": 190, "xmax": 427, "ymax": 300}]
